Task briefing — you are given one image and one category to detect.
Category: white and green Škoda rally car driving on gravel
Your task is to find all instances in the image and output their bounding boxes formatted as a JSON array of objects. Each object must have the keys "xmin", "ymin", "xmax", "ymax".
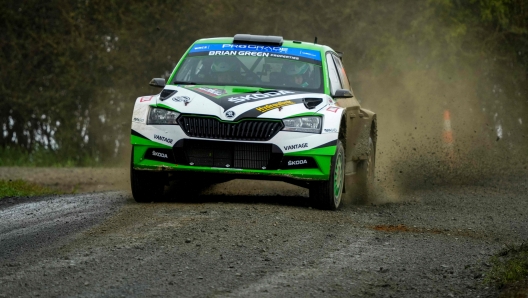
[{"xmin": 131, "ymin": 34, "xmax": 377, "ymax": 210}]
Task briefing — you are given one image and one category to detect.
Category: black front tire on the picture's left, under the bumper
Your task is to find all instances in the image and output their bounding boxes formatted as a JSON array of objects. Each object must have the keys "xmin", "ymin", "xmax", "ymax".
[{"xmin": 130, "ymin": 149, "xmax": 166, "ymax": 203}]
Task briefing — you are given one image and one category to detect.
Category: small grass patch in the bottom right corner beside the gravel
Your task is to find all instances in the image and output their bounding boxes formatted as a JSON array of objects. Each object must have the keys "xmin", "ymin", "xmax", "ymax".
[{"xmin": 486, "ymin": 243, "xmax": 528, "ymax": 297}]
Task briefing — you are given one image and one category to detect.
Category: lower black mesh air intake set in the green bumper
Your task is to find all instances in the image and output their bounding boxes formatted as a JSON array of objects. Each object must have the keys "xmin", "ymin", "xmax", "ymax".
[{"xmin": 174, "ymin": 139, "xmax": 282, "ymax": 169}]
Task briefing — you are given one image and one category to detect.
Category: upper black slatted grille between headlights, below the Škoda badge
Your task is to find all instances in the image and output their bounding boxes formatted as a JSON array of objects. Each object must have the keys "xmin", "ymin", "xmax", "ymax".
[{"xmin": 178, "ymin": 115, "xmax": 284, "ymax": 141}]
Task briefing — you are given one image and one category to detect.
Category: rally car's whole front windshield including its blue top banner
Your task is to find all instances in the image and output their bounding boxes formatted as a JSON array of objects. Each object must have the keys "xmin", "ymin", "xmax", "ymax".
[{"xmin": 172, "ymin": 44, "xmax": 323, "ymax": 92}]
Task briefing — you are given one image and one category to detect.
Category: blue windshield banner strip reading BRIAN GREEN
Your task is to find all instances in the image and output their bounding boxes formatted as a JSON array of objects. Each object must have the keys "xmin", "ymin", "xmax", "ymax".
[{"xmin": 189, "ymin": 43, "xmax": 321, "ymax": 61}]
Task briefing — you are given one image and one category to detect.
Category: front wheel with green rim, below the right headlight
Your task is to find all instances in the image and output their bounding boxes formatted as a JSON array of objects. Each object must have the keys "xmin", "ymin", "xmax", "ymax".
[{"xmin": 309, "ymin": 140, "xmax": 345, "ymax": 210}]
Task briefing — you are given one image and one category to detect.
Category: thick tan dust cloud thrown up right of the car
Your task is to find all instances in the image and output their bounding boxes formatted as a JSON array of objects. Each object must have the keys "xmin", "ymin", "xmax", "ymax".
[{"xmin": 360, "ymin": 53, "xmax": 528, "ymax": 203}]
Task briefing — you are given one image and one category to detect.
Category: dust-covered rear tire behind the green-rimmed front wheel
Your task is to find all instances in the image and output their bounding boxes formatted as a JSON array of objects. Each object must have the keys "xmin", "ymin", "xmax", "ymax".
[{"xmin": 356, "ymin": 136, "xmax": 376, "ymax": 203}]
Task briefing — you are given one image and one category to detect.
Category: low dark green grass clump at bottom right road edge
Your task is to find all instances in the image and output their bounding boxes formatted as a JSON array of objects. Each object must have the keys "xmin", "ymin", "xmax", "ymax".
[{"xmin": 486, "ymin": 243, "xmax": 528, "ymax": 288}]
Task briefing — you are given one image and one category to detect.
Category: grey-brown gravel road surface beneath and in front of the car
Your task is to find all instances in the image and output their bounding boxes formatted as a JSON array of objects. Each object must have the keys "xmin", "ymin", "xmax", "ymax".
[{"xmin": 0, "ymin": 168, "xmax": 528, "ymax": 297}]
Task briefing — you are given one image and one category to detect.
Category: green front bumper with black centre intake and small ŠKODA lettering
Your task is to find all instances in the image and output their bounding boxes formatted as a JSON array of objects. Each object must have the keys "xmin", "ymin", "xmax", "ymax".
[{"xmin": 132, "ymin": 136, "xmax": 335, "ymax": 180}]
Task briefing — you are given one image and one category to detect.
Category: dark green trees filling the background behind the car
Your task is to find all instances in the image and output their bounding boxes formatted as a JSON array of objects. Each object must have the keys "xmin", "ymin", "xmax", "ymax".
[{"xmin": 0, "ymin": 0, "xmax": 528, "ymax": 165}]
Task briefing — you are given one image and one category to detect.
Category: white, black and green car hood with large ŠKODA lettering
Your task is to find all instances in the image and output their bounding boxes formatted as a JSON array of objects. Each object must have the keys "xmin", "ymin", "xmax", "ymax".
[{"xmin": 156, "ymin": 85, "xmax": 331, "ymax": 121}]
